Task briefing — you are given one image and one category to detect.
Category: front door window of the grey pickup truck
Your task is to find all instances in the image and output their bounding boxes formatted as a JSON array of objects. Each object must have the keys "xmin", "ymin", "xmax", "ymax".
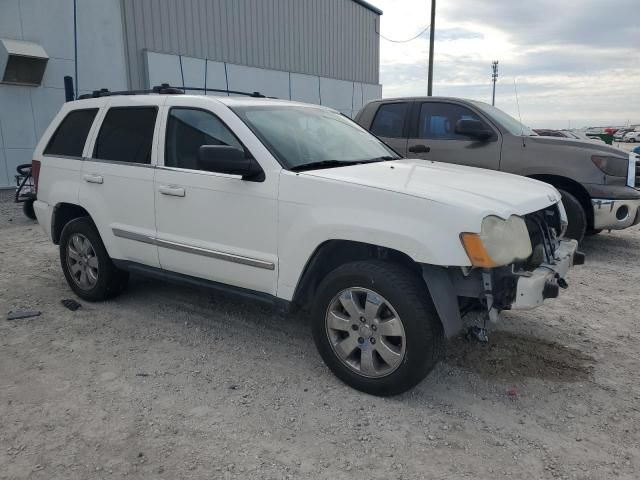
[{"xmin": 418, "ymin": 102, "xmax": 489, "ymax": 140}]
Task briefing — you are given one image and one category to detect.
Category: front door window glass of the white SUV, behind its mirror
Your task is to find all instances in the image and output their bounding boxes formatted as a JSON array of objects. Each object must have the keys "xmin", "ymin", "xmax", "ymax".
[{"xmin": 164, "ymin": 108, "xmax": 244, "ymax": 170}]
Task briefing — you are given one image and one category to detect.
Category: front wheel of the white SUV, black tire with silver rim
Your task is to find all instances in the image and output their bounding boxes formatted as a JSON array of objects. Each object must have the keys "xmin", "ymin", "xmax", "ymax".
[{"xmin": 312, "ymin": 260, "xmax": 445, "ymax": 396}]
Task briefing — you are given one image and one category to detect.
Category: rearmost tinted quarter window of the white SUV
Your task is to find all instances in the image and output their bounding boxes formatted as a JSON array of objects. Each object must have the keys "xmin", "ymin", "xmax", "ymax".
[{"xmin": 44, "ymin": 108, "xmax": 98, "ymax": 157}]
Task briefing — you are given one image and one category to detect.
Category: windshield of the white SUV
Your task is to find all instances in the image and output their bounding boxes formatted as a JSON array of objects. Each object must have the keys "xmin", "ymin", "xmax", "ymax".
[{"xmin": 233, "ymin": 106, "xmax": 400, "ymax": 169}]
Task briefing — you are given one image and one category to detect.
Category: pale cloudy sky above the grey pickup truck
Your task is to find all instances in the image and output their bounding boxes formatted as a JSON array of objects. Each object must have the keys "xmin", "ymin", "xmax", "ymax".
[{"xmin": 370, "ymin": 0, "xmax": 640, "ymax": 128}]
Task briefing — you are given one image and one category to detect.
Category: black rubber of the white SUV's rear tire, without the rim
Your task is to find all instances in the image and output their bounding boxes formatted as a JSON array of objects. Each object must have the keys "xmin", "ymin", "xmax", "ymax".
[{"xmin": 60, "ymin": 217, "xmax": 129, "ymax": 302}]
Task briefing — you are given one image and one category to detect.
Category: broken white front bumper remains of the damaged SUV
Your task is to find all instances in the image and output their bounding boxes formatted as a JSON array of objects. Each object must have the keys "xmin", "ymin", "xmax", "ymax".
[{"xmin": 511, "ymin": 240, "xmax": 584, "ymax": 310}]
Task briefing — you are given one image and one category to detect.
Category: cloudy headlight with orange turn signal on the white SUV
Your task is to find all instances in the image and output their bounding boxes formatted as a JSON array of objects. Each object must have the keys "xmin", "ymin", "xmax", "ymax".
[{"xmin": 460, "ymin": 215, "xmax": 531, "ymax": 268}]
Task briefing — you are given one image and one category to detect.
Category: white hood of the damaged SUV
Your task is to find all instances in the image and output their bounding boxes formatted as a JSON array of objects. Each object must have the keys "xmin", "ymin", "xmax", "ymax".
[{"xmin": 301, "ymin": 159, "xmax": 561, "ymax": 219}]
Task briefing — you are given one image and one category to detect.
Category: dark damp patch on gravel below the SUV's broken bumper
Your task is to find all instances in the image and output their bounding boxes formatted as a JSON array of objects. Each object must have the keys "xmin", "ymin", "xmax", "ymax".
[{"xmin": 445, "ymin": 330, "xmax": 595, "ymax": 382}]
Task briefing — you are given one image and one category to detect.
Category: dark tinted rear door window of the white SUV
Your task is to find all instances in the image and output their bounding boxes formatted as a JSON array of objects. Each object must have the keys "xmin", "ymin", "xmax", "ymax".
[{"xmin": 93, "ymin": 107, "xmax": 158, "ymax": 165}]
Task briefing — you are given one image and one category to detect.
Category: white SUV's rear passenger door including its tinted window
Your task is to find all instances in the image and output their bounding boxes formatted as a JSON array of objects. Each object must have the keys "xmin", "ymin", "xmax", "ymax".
[{"xmin": 80, "ymin": 96, "xmax": 160, "ymax": 267}]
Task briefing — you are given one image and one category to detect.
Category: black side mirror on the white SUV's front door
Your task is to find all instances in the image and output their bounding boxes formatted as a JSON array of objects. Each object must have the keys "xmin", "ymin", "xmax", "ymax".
[{"xmin": 198, "ymin": 145, "xmax": 264, "ymax": 182}]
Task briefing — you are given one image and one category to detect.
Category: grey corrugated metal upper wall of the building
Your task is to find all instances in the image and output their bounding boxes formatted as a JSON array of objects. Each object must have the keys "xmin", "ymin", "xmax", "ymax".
[{"xmin": 122, "ymin": 0, "xmax": 380, "ymax": 88}]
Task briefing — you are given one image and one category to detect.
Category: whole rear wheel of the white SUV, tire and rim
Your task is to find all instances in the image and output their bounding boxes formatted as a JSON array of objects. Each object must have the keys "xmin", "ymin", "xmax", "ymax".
[{"xmin": 60, "ymin": 217, "xmax": 129, "ymax": 302}]
